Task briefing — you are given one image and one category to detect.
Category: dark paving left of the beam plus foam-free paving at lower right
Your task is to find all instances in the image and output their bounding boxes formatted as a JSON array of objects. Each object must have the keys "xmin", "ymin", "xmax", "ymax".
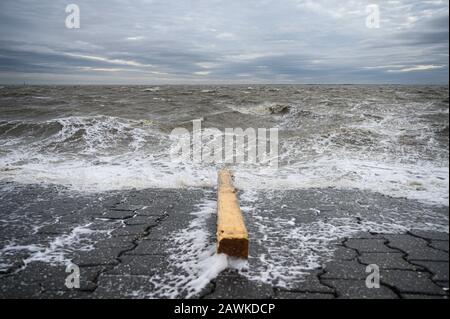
[{"xmin": 0, "ymin": 185, "xmax": 449, "ymax": 299}]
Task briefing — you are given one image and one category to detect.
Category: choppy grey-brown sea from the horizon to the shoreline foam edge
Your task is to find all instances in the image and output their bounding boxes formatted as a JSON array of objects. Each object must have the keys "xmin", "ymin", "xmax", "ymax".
[{"xmin": 0, "ymin": 86, "xmax": 449, "ymax": 204}]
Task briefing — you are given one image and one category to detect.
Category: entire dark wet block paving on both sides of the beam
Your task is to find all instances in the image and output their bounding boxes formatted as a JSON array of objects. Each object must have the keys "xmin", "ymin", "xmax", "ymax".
[{"xmin": 0, "ymin": 183, "xmax": 449, "ymax": 299}]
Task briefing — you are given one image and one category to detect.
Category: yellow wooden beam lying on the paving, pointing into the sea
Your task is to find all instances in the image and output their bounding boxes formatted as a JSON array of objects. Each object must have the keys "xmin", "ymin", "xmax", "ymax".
[{"xmin": 217, "ymin": 170, "xmax": 248, "ymax": 259}]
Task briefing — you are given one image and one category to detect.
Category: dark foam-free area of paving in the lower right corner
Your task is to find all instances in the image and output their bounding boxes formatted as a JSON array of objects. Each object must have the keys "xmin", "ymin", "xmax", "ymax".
[{"xmin": 204, "ymin": 231, "xmax": 449, "ymax": 299}]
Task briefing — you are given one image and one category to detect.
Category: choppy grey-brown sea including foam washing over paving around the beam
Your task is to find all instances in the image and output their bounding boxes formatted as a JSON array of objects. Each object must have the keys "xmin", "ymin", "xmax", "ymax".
[{"xmin": 0, "ymin": 86, "xmax": 449, "ymax": 297}]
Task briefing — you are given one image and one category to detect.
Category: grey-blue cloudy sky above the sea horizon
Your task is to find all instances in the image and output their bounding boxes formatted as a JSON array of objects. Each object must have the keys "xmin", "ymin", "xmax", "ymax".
[{"xmin": 0, "ymin": 0, "xmax": 449, "ymax": 84}]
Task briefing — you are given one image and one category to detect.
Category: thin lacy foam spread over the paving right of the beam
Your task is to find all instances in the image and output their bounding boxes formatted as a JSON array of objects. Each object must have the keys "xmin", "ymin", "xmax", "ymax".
[{"xmin": 237, "ymin": 190, "xmax": 449, "ymax": 288}]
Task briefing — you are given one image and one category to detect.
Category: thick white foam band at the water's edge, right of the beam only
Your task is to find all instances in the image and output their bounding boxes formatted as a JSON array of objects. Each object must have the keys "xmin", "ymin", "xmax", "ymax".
[{"xmin": 235, "ymin": 158, "xmax": 449, "ymax": 206}]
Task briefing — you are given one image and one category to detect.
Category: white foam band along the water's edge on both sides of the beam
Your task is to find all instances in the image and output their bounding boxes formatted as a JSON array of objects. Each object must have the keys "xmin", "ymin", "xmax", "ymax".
[{"xmin": 0, "ymin": 157, "xmax": 449, "ymax": 206}]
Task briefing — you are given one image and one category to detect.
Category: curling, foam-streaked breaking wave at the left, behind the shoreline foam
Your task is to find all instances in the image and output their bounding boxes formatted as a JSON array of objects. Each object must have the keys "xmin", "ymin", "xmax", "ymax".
[{"xmin": 0, "ymin": 115, "xmax": 162, "ymax": 155}]
